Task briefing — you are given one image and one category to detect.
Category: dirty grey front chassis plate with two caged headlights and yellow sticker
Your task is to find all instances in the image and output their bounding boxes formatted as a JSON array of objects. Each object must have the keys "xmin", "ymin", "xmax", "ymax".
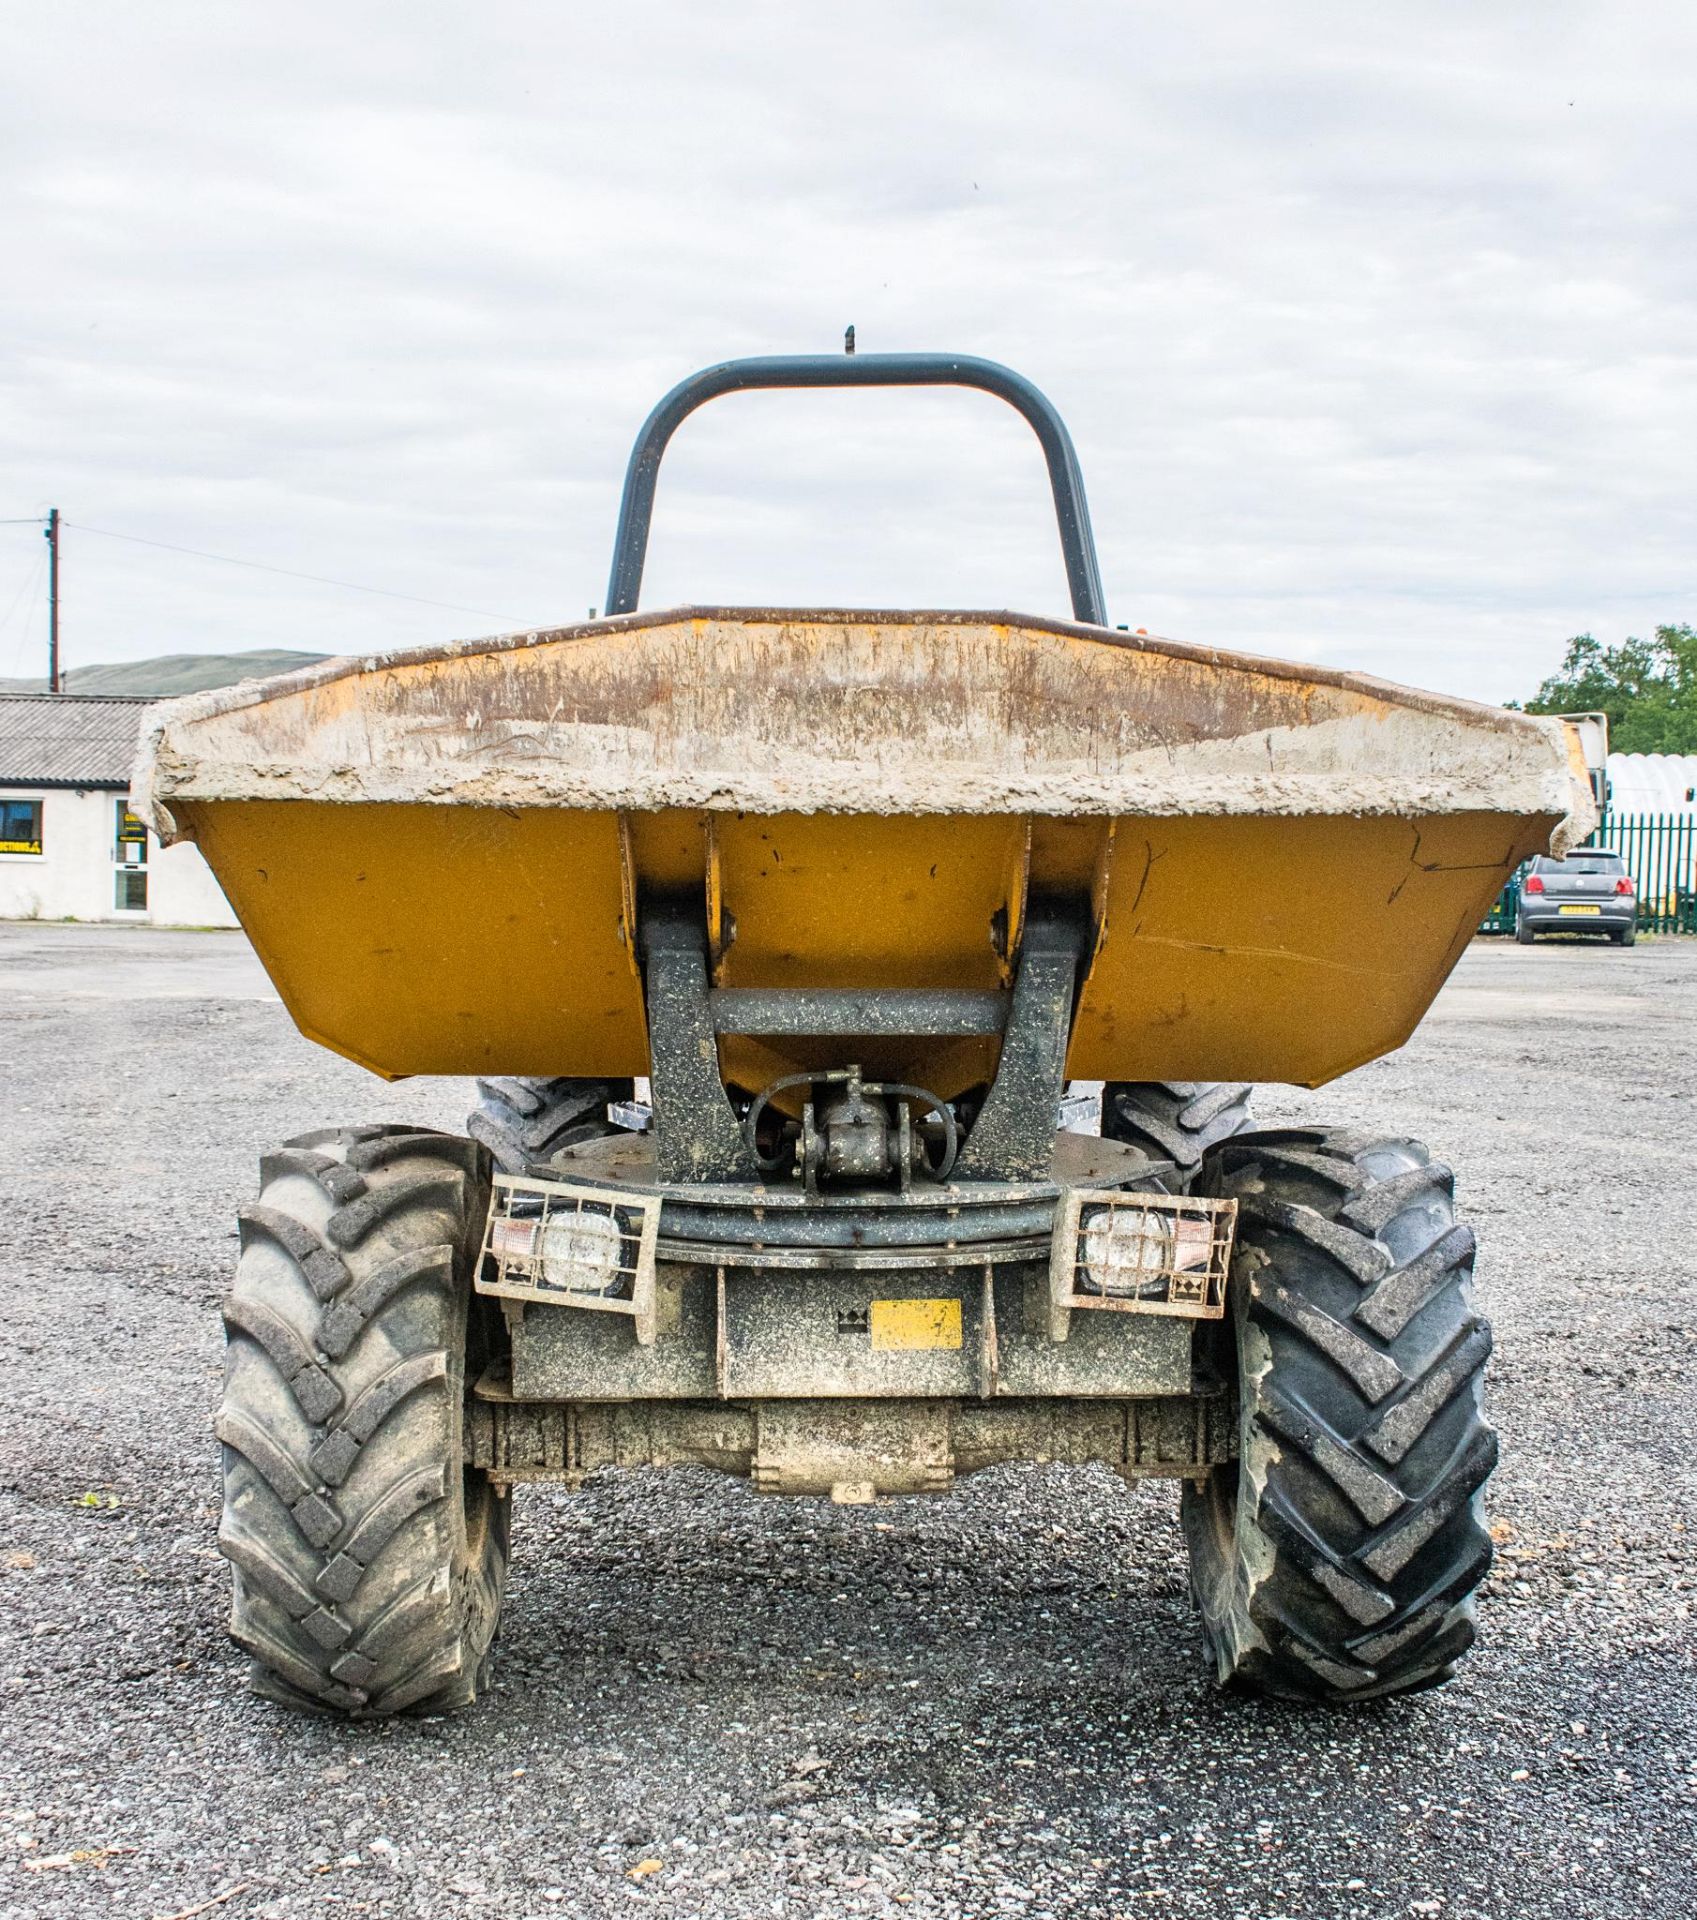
[{"xmin": 476, "ymin": 1133, "xmax": 1236, "ymax": 1402}]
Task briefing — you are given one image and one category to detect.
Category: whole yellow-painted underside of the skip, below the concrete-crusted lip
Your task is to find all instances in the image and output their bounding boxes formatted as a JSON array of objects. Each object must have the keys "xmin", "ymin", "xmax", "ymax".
[{"xmin": 173, "ymin": 797, "xmax": 1557, "ymax": 1096}]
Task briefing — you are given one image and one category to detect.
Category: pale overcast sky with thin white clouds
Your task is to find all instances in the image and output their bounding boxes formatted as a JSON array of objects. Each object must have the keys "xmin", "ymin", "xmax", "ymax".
[{"xmin": 0, "ymin": 0, "xmax": 1697, "ymax": 701}]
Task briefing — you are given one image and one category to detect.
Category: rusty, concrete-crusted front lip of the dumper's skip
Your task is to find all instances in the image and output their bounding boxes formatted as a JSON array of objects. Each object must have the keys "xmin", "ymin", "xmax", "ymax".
[{"xmin": 132, "ymin": 609, "xmax": 1591, "ymax": 829}]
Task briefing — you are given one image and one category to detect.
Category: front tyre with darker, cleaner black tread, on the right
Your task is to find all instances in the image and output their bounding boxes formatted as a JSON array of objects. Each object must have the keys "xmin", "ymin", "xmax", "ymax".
[{"xmin": 1183, "ymin": 1129, "xmax": 1497, "ymax": 1703}]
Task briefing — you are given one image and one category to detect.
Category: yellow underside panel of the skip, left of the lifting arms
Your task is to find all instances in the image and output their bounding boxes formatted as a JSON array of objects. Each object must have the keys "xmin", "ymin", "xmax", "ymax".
[{"xmin": 180, "ymin": 801, "xmax": 647, "ymax": 1079}]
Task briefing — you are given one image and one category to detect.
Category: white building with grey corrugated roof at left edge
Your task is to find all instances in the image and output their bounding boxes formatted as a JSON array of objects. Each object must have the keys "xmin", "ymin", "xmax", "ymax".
[{"xmin": 0, "ymin": 693, "xmax": 236, "ymax": 927}]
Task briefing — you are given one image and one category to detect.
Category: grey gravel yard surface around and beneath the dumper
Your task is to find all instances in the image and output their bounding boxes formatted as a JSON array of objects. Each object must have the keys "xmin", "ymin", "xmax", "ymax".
[{"xmin": 0, "ymin": 925, "xmax": 1697, "ymax": 1920}]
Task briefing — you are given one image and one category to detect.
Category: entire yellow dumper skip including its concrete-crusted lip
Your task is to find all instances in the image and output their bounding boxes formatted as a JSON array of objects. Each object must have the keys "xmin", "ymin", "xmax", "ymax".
[{"xmin": 136, "ymin": 609, "xmax": 1591, "ymax": 1094}]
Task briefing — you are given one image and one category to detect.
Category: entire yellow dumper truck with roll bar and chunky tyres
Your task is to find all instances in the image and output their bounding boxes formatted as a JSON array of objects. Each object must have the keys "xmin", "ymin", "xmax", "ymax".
[{"xmin": 136, "ymin": 355, "xmax": 1591, "ymax": 1715}]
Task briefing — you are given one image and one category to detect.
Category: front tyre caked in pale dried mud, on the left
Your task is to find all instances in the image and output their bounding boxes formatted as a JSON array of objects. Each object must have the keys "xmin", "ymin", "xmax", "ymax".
[{"xmin": 217, "ymin": 1127, "xmax": 509, "ymax": 1718}]
